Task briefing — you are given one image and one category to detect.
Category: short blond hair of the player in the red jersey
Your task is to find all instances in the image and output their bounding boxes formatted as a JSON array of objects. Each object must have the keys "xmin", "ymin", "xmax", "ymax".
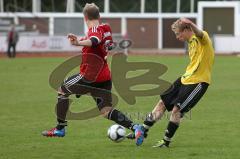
[{"xmin": 83, "ymin": 3, "xmax": 100, "ymax": 20}]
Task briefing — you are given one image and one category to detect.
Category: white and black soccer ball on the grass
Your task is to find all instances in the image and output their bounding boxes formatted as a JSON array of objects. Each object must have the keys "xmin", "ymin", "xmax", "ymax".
[{"xmin": 107, "ymin": 124, "xmax": 126, "ymax": 142}]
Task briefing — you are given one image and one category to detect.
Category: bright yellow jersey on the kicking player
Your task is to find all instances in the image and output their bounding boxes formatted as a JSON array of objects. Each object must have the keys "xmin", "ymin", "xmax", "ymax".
[{"xmin": 181, "ymin": 31, "xmax": 214, "ymax": 84}]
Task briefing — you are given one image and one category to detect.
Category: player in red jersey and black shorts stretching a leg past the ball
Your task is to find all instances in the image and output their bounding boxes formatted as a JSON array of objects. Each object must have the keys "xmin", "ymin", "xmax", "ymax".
[{"xmin": 42, "ymin": 3, "xmax": 144, "ymax": 146}]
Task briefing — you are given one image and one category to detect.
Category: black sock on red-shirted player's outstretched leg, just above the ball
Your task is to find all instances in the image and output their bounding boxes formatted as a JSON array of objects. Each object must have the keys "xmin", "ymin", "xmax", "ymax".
[{"xmin": 108, "ymin": 109, "xmax": 133, "ymax": 130}]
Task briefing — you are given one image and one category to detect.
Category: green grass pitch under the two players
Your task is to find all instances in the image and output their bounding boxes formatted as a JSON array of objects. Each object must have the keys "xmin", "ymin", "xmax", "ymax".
[{"xmin": 0, "ymin": 56, "xmax": 240, "ymax": 159}]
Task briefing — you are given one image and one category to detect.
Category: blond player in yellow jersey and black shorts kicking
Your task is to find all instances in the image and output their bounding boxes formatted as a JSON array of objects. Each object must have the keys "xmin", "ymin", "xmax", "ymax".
[{"xmin": 128, "ymin": 18, "xmax": 214, "ymax": 147}]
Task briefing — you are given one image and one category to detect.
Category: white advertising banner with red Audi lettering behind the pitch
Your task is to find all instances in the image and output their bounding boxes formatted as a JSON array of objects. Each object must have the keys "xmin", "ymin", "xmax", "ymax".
[{"xmin": 0, "ymin": 36, "xmax": 81, "ymax": 53}]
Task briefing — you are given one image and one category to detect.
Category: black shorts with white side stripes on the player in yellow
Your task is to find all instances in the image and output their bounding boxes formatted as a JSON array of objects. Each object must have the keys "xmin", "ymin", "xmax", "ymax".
[{"xmin": 160, "ymin": 78, "xmax": 209, "ymax": 114}]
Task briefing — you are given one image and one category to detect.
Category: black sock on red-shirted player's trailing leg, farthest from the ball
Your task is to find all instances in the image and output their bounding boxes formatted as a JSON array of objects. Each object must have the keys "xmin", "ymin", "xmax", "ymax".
[{"xmin": 56, "ymin": 95, "xmax": 69, "ymax": 130}]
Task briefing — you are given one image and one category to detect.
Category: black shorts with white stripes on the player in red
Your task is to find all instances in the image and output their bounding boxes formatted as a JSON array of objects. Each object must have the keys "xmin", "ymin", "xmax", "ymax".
[{"xmin": 61, "ymin": 74, "xmax": 112, "ymax": 110}]
